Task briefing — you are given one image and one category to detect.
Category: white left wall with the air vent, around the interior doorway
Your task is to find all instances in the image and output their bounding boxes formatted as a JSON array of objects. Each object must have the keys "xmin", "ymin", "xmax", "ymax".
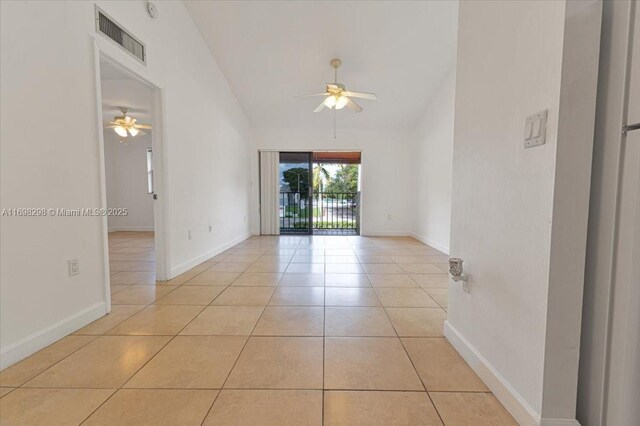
[{"xmin": 0, "ymin": 1, "xmax": 250, "ymax": 367}]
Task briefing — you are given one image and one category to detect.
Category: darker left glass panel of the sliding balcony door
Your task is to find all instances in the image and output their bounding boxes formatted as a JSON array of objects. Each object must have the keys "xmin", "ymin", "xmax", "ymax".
[{"xmin": 279, "ymin": 152, "xmax": 313, "ymax": 235}]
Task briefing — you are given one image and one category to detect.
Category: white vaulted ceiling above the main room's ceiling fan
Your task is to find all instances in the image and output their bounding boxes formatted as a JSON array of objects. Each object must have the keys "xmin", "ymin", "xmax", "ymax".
[{"xmin": 185, "ymin": 1, "xmax": 458, "ymax": 128}]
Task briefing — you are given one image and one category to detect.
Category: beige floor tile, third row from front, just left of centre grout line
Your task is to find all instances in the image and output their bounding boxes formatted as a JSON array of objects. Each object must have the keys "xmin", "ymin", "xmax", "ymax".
[{"xmin": 253, "ymin": 306, "xmax": 324, "ymax": 336}]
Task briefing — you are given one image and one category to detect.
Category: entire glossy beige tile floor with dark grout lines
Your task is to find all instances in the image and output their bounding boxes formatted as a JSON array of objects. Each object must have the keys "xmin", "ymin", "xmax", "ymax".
[{"xmin": 0, "ymin": 232, "xmax": 516, "ymax": 426}]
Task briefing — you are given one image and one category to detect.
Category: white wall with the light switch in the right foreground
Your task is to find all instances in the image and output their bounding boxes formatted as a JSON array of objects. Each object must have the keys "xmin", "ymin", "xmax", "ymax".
[{"xmin": 446, "ymin": 1, "xmax": 601, "ymax": 425}]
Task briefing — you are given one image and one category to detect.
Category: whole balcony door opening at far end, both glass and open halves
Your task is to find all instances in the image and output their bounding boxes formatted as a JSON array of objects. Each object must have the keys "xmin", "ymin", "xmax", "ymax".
[{"xmin": 279, "ymin": 151, "xmax": 361, "ymax": 235}]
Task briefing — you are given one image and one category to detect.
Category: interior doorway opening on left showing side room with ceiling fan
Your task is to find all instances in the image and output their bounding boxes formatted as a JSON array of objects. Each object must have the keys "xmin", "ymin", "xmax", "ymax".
[{"xmin": 97, "ymin": 55, "xmax": 166, "ymax": 305}]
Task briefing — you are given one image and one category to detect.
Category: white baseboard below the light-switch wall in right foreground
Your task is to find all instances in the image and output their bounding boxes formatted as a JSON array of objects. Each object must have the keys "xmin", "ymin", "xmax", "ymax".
[{"xmin": 444, "ymin": 321, "xmax": 550, "ymax": 426}]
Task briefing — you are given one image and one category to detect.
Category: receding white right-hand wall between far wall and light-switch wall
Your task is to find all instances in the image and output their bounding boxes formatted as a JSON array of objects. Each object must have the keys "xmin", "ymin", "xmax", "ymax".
[{"xmin": 412, "ymin": 66, "xmax": 456, "ymax": 253}]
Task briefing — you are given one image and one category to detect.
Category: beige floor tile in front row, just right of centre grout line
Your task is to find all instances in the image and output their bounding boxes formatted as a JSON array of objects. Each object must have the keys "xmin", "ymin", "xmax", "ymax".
[{"xmin": 324, "ymin": 391, "xmax": 442, "ymax": 426}]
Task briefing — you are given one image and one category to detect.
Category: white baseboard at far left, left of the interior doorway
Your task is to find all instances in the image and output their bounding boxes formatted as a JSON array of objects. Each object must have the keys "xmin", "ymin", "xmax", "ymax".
[{"xmin": 0, "ymin": 302, "xmax": 107, "ymax": 370}]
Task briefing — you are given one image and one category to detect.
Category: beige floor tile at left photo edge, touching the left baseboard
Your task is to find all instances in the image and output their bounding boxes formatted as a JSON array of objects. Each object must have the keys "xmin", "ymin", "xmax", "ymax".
[{"xmin": 0, "ymin": 336, "xmax": 95, "ymax": 387}]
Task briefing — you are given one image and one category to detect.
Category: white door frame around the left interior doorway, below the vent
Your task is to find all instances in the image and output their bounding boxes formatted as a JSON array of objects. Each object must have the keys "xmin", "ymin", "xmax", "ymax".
[{"xmin": 93, "ymin": 36, "xmax": 170, "ymax": 313}]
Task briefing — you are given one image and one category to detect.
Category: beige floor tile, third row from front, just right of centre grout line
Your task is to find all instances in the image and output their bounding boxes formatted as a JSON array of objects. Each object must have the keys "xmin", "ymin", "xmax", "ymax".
[{"xmin": 325, "ymin": 307, "xmax": 396, "ymax": 337}]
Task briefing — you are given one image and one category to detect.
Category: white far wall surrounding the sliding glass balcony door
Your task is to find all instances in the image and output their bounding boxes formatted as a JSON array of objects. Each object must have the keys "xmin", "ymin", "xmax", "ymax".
[{"xmin": 254, "ymin": 126, "xmax": 415, "ymax": 235}]
